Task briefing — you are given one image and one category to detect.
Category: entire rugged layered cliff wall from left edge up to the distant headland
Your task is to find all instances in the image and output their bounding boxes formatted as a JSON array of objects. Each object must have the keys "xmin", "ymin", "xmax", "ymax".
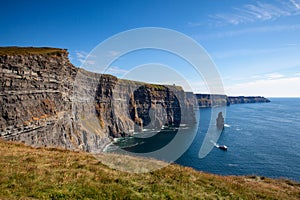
[{"xmin": 0, "ymin": 48, "xmax": 196, "ymax": 152}]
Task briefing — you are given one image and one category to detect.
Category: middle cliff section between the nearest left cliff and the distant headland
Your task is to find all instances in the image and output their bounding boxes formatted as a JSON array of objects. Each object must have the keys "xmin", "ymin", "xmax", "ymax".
[{"xmin": 73, "ymin": 70, "xmax": 197, "ymax": 141}]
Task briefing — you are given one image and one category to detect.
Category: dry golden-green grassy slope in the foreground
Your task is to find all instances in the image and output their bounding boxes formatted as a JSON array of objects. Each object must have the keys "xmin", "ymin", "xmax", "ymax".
[{"xmin": 0, "ymin": 141, "xmax": 300, "ymax": 199}]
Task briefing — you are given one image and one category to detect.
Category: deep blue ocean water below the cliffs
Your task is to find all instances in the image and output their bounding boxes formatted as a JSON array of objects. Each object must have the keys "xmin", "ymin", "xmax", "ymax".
[{"xmin": 105, "ymin": 98, "xmax": 300, "ymax": 181}]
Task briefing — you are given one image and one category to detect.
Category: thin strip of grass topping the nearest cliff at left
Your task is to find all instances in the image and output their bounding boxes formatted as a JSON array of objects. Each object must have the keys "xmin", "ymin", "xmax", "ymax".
[{"xmin": 0, "ymin": 46, "xmax": 67, "ymax": 55}]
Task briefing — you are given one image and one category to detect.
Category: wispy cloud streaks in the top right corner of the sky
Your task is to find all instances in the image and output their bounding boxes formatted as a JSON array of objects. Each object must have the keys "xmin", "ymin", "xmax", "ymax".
[{"xmin": 209, "ymin": 0, "xmax": 300, "ymax": 25}]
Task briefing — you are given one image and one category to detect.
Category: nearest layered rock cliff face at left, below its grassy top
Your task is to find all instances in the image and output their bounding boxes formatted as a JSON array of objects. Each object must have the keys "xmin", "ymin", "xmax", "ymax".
[{"xmin": 0, "ymin": 50, "xmax": 96, "ymax": 149}]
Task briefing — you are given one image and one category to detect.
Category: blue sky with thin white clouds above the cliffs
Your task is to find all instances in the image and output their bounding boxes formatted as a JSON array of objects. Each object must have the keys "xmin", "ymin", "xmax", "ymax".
[{"xmin": 0, "ymin": 0, "xmax": 300, "ymax": 97}]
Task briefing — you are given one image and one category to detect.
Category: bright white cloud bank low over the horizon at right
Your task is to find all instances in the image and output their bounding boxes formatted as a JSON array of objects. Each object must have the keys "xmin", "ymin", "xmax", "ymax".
[{"xmin": 226, "ymin": 77, "xmax": 300, "ymax": 97}]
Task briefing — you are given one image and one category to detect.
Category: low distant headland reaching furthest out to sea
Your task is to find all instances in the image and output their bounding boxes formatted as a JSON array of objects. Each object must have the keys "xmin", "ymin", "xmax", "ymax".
[{"xmin": 196, "ymin": 94, "xmax": 270, "ymax": 107}]
